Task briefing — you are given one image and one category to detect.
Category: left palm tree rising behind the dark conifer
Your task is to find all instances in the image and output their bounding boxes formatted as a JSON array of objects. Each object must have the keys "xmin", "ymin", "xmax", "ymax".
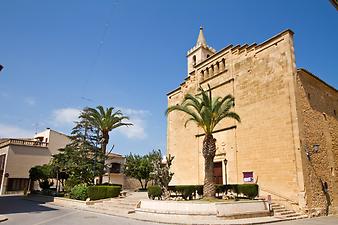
[{"xmin": 81, "ymin": 105, "xmax": 133, "ymax": 184}]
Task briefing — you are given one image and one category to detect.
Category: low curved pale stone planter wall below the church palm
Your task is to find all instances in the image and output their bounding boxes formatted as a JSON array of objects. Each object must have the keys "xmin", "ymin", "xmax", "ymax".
[{"xmin": 135, "ymin": 200, "xmax": 271, "ymax": 219}]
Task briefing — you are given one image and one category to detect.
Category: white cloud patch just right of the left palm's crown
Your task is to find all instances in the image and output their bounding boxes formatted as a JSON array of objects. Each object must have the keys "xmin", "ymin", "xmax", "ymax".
[{"xmin": 118, "ymin": 107, "xmax": 150, "ymax": 139}]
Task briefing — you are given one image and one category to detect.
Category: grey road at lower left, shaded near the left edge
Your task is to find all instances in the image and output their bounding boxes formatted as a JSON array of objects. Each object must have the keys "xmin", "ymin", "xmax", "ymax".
[{"xmin": 0, "ymin": 196, "xmax": 164, "ymax": 225}]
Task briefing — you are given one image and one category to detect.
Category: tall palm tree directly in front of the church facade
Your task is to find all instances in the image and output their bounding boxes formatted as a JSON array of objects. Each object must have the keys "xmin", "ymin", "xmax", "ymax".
[{"xmin": 166, "ymin": 85, "xmax": 240, "ymax": 198}]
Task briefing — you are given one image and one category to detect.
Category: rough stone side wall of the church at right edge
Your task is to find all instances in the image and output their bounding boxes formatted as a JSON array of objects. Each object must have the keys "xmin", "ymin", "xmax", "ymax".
[{"xmin": 296, "ymin": 70, "xmax": 338, "ymax": 215}]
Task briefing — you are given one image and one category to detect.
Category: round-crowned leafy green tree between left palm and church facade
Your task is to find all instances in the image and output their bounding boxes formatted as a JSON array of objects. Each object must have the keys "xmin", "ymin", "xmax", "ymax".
[{"xmin": 123, "ymin": 151, "xmax": 161, "ymax": 189}]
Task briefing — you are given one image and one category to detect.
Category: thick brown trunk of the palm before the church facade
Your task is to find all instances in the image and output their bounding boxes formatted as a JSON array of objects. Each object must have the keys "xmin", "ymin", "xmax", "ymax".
[{"xmin": 203, "ymin": 134, "xmax": 216, "ymax": 198}]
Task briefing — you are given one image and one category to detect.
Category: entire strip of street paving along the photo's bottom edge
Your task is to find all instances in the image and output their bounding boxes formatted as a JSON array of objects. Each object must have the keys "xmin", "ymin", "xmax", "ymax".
[{"xmin": 0, "ymin": 196, "xmax": 338, "ymax": 225}]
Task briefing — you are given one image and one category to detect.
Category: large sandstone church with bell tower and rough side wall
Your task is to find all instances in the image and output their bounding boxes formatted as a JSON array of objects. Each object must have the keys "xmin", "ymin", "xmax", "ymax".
[{"xmin": 167, "ymin": 28, "xmax": 338, "ymax": 214}]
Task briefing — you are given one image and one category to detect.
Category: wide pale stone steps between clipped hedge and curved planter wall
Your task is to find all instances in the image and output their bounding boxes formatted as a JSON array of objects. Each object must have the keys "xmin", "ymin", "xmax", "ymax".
[{"xmin": 89, "ymin": 192, "xmax": 147, "ymax": 215}]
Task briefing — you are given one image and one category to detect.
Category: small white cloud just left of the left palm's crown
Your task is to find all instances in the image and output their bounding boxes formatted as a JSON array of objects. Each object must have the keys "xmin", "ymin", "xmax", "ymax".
[{"xmin": 52, "ymin": 108, "xmax": 81, "ymax": 126}]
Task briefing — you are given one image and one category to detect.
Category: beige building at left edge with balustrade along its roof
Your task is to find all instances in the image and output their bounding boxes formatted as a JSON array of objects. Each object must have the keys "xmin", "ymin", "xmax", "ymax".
[{"xmin": 0, "ymin": 128, "xmax": 70, "ymax": 195}]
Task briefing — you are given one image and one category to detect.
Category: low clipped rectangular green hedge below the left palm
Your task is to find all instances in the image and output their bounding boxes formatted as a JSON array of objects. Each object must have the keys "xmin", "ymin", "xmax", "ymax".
[{"xmin": 88, "ymin": 186, "xmax": 121, "ymax": 200}]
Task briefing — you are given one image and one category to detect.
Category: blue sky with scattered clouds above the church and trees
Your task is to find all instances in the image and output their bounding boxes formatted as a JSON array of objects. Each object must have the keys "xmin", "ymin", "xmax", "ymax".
[{"xmin": 0, "ymin": 0, "xmax": 338, "ymax": 154}]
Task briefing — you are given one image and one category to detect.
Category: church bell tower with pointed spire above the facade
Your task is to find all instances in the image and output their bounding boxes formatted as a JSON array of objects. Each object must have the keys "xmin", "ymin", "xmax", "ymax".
[{"xmin": 187, "ymin": 26, "xmax": 216, "ymax": 76}]
